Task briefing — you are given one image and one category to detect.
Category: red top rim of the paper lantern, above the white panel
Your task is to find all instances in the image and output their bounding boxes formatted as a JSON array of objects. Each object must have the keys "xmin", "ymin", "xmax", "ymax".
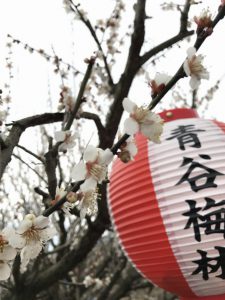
[{"xmin": 159, "ymin": 108, "xmax": 199, "ymax": 122}]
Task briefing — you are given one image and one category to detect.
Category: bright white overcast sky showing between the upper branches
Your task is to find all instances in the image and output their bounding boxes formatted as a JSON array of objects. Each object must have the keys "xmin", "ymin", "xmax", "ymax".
[{"xmin": 0, "ymin": 0, "xmax": 225, "ymax": 121}]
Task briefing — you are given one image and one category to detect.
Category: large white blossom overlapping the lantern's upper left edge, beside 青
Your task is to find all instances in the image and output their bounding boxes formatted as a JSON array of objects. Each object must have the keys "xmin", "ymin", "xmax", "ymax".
[{"xmin": 123, "ymin": 98, "xmax": 163, "ymax": 143}]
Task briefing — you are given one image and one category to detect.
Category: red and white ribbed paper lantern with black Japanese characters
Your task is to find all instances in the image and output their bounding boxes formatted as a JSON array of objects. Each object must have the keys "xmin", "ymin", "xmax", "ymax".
[{"xmin": 109, "ymin": 109, "xmax": 225, "ymax": 300}]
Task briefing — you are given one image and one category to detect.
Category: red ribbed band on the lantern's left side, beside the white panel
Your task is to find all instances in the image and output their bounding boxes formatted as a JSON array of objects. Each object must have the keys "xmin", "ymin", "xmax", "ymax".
[{"xmin": 109, "ymin": 135, "xmax": 195, "ymax": 297}]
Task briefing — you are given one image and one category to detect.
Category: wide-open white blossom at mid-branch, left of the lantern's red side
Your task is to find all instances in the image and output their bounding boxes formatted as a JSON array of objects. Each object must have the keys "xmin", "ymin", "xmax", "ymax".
[{"xmin": 72, "ymin": 145, "xmax": 113, "ymax": 191}]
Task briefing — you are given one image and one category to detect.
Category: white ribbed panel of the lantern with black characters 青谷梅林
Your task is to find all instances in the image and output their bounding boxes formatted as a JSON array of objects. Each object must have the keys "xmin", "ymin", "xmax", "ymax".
[{"xmin": 148, "ymin": 118, "xmax": 225, "ymax": 296}]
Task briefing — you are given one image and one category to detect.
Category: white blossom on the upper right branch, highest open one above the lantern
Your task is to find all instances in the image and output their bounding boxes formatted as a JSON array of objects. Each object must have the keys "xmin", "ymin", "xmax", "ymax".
[{"xmin": 183, "ymin": 47, "xmax": 209, "ymax": 90}]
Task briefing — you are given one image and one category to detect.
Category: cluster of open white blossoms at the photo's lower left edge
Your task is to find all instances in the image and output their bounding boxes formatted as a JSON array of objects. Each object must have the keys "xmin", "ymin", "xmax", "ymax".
[{"xmin": 0, "ymin": 214, "xmax": 56, "ymax": 280}]
